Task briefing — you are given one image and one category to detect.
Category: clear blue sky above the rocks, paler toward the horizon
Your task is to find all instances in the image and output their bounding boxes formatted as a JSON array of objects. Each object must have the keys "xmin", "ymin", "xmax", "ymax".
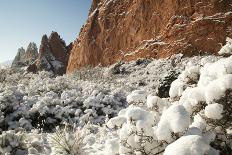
[{"xmin": 0, "ymin": 0, "xmax": 91, "ymax": 62}]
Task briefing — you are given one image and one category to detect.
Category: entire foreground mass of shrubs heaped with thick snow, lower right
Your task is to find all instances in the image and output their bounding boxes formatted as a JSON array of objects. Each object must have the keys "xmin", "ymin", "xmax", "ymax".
[{"xmin": 105, "ymin": 49, "xmax": 232, "ymax": 155}]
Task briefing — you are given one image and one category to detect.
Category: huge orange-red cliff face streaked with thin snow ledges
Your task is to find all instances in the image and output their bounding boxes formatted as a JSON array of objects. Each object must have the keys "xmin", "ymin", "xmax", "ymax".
[{"xmin": 67, "ymin": 0, "xmax": 232, "ymax": 72}]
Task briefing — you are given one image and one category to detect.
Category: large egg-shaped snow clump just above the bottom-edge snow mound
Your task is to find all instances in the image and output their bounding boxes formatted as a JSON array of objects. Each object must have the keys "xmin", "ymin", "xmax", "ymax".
[{"xmin": 155, "ymin": 105, "xmax": 190, "ymax": 140}]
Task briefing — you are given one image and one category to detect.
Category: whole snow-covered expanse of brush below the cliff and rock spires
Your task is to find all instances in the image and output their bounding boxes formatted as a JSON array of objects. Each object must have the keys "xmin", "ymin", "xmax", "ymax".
[{"xmin": 0, "ymin": 39, "xmax": 232, "ymax": 155}]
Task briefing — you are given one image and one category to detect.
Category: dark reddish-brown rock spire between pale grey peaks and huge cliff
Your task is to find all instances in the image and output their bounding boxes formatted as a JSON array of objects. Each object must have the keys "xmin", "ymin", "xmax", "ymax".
[{"xmin": 27, "ymin": 32, "xmax": 71, "ymax": 75}]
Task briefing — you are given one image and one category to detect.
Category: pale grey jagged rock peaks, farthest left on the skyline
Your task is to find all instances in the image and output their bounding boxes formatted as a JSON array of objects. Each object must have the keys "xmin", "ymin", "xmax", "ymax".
[{"xmin": 11, "ymin": 42, "xmax": 38, "ymax": 68}]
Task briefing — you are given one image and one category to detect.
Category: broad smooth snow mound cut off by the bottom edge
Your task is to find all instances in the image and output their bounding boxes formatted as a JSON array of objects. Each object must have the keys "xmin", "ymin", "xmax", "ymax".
[{"xmin": 164, "ymin": 135, "xmax": 210, "ymax": 155}]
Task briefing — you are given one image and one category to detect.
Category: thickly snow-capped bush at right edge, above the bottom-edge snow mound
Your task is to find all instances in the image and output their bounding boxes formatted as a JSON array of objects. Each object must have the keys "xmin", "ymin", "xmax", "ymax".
[{"xmin": 171, "ymin": 54, "xmax": 232, "ymax": 152}]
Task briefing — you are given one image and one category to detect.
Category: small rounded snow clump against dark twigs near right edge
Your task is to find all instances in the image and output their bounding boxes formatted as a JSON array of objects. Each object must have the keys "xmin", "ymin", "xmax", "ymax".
[{"xmin": 205, "ymin": 103, "xmax": 223, "ymax": 119}]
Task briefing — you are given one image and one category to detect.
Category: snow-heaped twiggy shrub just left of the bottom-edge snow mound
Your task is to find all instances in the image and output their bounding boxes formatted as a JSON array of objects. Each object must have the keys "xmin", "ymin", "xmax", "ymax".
[{"xmin": 105, "ymin": 92, "xmax": 190, "ymax": 154}]
